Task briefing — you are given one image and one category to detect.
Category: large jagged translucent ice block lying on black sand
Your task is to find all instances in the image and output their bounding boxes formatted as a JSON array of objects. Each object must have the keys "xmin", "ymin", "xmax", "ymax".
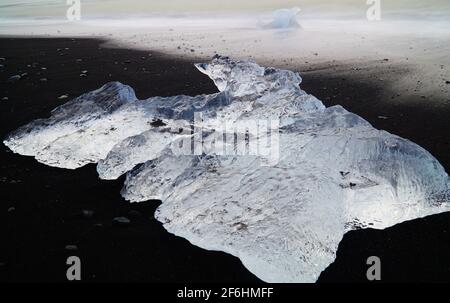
[{"xmin": 4, "ymin": 56, "xmax": 450, "ymax": 282}]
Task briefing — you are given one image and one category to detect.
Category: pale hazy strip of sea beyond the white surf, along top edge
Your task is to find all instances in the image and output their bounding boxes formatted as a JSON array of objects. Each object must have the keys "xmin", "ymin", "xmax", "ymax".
[{"xmin": 0, "ymin": 0, "xmax": 450, "ymax": 21}]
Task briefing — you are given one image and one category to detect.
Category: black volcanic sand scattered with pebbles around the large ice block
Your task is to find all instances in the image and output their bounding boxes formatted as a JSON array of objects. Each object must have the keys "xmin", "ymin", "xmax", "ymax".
[{"xmin": 0, "ymin": 37, "xmax": 450, "ymax": 282}]
